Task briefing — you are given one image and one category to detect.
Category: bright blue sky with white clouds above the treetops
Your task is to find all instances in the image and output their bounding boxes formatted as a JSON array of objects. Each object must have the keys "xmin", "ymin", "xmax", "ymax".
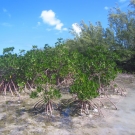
[{"xmin": 0, "ymin": 0, "xmax": 129, "ymax": 55}]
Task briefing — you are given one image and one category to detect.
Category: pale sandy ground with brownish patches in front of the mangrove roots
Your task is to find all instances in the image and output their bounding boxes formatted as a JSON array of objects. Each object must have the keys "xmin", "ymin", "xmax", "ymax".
[{"xmin": 0, "ymin": 75, "xmax": 135, "ymax": 135}]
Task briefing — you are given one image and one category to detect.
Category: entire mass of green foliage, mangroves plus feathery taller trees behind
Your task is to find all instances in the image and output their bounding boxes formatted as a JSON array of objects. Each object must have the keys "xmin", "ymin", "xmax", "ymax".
[{"xmin": 0, "ymin": 0, "xmax": 135, "ymax": 116}]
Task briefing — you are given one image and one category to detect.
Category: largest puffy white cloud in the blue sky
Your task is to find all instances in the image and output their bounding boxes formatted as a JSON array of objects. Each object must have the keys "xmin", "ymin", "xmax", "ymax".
[{"xmin": 40, "ymin": 10, "xmax": 65, "ymax": 30}]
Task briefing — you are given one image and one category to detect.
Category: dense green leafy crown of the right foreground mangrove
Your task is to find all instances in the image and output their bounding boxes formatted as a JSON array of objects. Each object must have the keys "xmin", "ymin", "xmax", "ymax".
[{"xmin": 70, "ymin": 46, "xmax": 118, "ymax": 101}]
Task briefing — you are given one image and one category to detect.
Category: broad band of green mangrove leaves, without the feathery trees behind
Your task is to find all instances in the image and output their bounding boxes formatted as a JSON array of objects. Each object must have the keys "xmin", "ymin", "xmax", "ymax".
[{"xmin": 0, "ymin": 39, "xmax": 117, "ymax": 102}]
